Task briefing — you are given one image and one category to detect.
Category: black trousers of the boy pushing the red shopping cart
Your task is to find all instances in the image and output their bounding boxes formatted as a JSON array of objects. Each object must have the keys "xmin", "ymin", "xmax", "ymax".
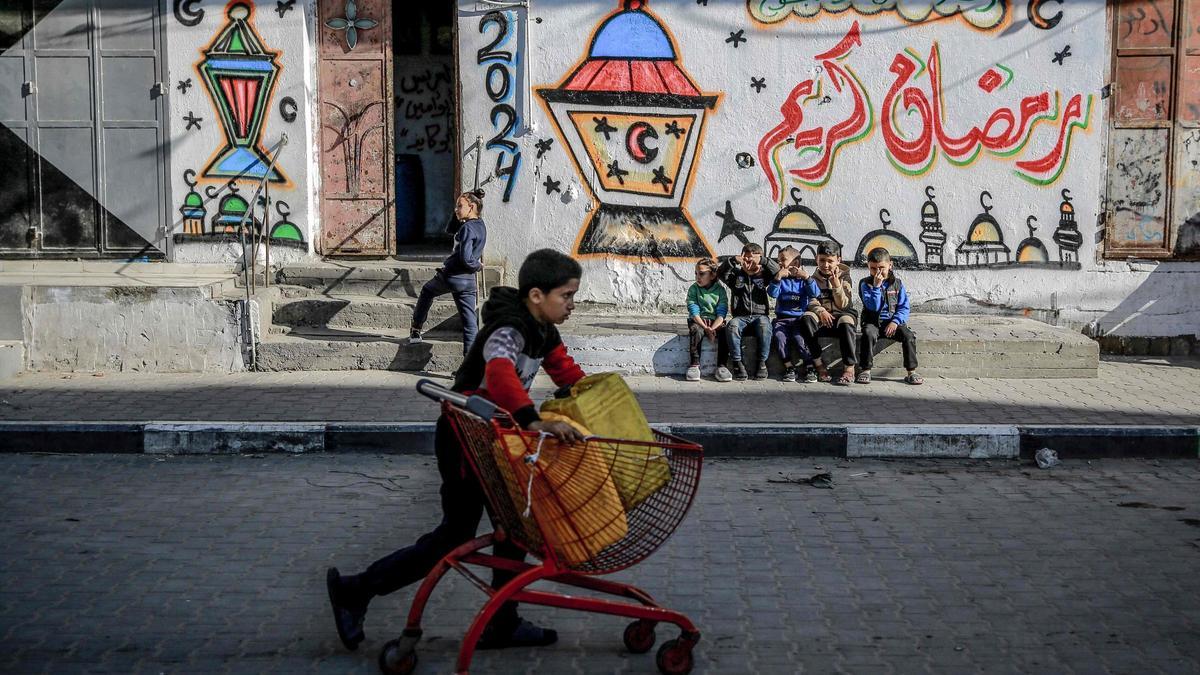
[{"xmin": 356, "ymin": 416, "xmax": 524, "ymax": 628}]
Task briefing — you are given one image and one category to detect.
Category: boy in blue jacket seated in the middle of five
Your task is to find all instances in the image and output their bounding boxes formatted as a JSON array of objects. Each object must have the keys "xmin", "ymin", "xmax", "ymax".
[{"xmin": 767, "ymin": 246, "xmax": 821, "ymax": 383}]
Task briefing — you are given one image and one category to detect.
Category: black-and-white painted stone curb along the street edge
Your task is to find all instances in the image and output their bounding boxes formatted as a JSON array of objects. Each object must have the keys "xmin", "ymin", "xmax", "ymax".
[{"xmin": 0, "ymin": 422, "xmax": 1200, "ymax": 459}]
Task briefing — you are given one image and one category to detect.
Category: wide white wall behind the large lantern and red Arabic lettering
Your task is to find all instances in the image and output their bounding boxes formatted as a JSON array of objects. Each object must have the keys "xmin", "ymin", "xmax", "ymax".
[{"xmin": 458, "ymin": 0, "xmax": 1200, "ymax": 335}]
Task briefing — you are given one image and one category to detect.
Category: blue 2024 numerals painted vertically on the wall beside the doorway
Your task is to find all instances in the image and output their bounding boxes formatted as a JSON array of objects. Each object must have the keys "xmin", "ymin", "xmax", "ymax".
[{"xmin": 475, "ymin": 11, "xmax": 521, "ymax": 203}]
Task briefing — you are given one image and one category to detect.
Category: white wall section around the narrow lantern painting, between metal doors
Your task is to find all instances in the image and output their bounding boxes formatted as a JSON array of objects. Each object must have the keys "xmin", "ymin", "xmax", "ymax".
[{"xmin": 163, "ymin": 0, "xmax": 319, "ymax": 263}]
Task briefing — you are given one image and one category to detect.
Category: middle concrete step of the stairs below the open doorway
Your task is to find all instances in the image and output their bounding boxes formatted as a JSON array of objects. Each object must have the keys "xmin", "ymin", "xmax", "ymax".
[{"xmin": 271, "ymin": 294, "xmax": 462, "ymax": 336}]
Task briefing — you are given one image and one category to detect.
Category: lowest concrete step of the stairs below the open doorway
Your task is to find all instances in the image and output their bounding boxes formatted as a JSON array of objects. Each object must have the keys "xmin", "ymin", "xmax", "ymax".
[{"xmin": 256, "ymin": 328, "xmax": 462, "ymax": 372}]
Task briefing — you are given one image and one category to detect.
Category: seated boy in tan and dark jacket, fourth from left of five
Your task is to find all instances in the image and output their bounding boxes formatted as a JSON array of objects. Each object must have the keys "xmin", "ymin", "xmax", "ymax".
[{"xmin": 800, "ymin": 244, "xmax": 858, "ymax": 386}]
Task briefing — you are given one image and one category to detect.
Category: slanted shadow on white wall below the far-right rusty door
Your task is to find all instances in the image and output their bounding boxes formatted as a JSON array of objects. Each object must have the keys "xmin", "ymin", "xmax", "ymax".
[{"xmin": 1097, "ymin": 263, "xmax": 1200, "ymax": 338}]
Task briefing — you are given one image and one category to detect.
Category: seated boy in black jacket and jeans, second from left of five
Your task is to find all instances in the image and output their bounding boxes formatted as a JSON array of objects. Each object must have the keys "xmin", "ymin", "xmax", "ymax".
[{"xmin": 716, "ymin": 244, "xmax": 779, "ymax": 380}]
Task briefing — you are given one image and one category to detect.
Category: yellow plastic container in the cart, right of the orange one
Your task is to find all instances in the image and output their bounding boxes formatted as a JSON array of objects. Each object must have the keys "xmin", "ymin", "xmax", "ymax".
[{"xmin": 541, "ymin": 372, "xmax": 671, "ymax": 510}]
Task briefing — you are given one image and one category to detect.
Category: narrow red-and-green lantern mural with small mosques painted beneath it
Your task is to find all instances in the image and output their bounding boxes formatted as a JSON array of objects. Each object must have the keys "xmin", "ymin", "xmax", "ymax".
[{"xmin": 174, "ymin": 0, "xmax": 307, "ymax": 249}]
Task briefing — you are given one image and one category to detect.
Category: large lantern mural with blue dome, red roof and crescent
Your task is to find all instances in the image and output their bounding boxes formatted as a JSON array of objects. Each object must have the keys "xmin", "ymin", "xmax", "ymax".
[{"xmin": 536, "ymin": 0, "xmax": 720, "ymax": 261}]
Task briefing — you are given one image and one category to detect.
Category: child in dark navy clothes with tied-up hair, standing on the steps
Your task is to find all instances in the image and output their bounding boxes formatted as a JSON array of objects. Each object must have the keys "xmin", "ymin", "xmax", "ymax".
[{"xmin": 408, "ymin": 190, "xmax": 487, "ymax": 354}]
